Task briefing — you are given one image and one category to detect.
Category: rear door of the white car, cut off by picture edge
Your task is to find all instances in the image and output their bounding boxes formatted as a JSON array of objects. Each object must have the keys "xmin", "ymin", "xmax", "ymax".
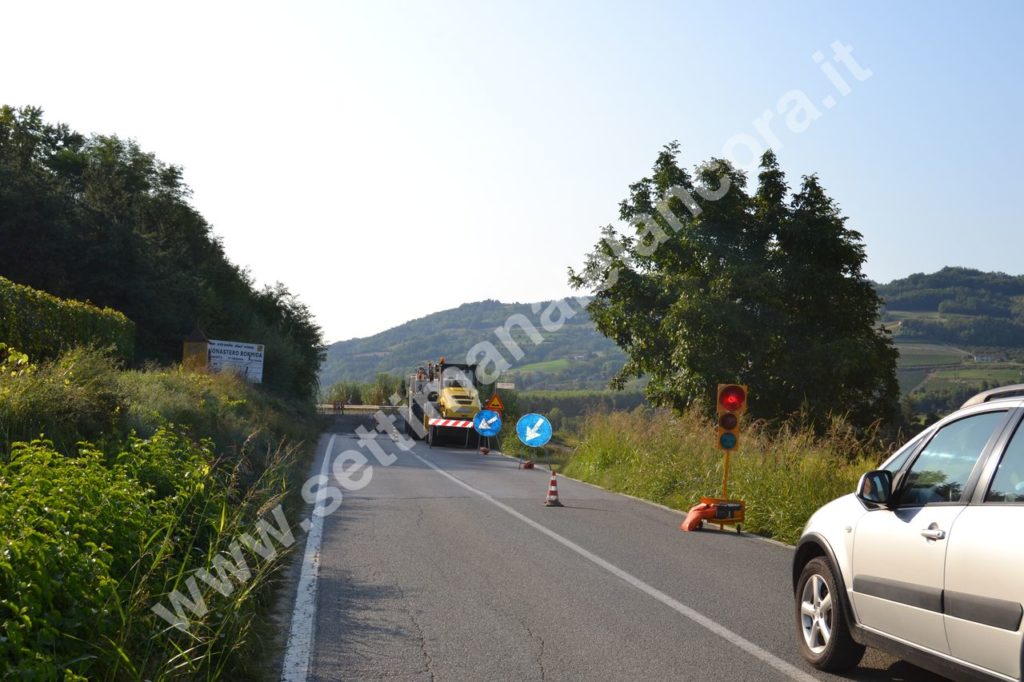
[{"xmin": 944, "ymin": 405, "xmax": 1024, "ymax": 679}]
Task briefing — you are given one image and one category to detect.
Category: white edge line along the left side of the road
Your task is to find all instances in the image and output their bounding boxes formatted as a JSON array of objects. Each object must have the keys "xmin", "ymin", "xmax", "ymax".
[{"xmin": 281, "ymin": 434, "xmax": 337, "ymax": 682}]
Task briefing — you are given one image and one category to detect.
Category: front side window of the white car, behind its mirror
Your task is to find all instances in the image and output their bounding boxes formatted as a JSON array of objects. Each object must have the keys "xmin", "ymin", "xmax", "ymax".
[{"xmin": 899, "ymin": 412, "xmax": 1007, "ymax": 505}]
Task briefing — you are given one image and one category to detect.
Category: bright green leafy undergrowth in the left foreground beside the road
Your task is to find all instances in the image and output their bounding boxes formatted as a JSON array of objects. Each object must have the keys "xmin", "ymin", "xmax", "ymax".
[{"xmin": 0, "ymin": 427, "xmax": 299, "ymax": 679}]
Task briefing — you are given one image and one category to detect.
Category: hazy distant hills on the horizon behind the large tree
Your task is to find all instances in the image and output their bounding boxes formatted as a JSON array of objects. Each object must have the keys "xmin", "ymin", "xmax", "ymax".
[{"xmin": 321, "ymin": 267, "xmax": 1024, "ymax": 392}]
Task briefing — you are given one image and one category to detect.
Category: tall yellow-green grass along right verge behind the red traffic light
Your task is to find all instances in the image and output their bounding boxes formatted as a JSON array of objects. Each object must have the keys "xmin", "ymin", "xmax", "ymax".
[{"xmin": 564, "ymin": 403, "xmax": 887, "ymax": 543}]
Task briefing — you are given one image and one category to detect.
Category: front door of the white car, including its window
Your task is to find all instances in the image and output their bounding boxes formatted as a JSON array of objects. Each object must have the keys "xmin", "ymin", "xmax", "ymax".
[{"xmin": 852, "ymin": 409, "xmax": 1009, "ymax": 653}]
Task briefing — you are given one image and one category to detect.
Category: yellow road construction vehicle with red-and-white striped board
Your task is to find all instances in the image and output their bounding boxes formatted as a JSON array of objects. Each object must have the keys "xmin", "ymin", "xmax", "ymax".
[{"xmin": 402, "ymin": 357, "xmax": 480, "ymax": 447}]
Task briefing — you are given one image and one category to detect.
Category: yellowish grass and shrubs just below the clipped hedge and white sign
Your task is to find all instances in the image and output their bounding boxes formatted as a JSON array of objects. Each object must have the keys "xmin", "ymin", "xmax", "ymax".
[{"xmin": 0, "ymin": 348, "xmax": 312, "ymax": 454}]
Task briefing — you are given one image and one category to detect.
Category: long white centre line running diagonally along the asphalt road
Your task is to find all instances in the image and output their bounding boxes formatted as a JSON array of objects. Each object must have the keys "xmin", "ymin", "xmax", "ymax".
[{"xmin": 410, "ymin": 446, "xmax": 816, "ymax": 682}]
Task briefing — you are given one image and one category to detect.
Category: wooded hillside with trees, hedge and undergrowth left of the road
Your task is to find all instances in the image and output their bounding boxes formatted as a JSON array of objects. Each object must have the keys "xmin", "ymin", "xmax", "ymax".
[{"xmin": 0, "ymin": 106, "xmax": 323, "ymax": 682}]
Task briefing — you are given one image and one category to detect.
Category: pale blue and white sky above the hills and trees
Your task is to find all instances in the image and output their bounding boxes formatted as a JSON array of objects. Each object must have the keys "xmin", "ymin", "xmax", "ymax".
[{"xmin": 0, "ymin": 0, "xmax": 1024, "ymax": 342}]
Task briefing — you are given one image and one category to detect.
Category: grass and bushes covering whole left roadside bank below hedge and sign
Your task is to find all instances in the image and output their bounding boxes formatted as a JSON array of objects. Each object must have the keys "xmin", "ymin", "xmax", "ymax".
[{"xmin": 0, "ymin": 349, "xmax": 315, "ymax": 680}]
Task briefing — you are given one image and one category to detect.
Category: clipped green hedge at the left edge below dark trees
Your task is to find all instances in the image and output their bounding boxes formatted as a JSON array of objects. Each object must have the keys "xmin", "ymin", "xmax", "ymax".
[{"xmin": 0, "ymin": 276, "xmax": 135, "ymax": 360}]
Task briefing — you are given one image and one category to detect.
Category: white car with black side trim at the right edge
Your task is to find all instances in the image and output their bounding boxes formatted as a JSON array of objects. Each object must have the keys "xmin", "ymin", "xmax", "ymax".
[{"xmin": 793, "ymin": 384, "xmax": 1024, "ymax": 680}]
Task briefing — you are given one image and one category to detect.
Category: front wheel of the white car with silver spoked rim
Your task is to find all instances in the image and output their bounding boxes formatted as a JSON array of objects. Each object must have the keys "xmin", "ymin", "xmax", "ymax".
[{"xmin": 796, "ymin": 556, "xmax": 864, "ymax": 671}]
